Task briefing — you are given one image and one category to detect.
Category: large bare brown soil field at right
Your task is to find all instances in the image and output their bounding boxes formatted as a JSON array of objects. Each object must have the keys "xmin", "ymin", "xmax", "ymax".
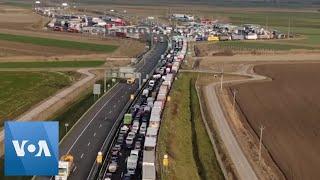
[{"xmin": 231, "ymin": 63, "xmax": 320, "ymax": 180}]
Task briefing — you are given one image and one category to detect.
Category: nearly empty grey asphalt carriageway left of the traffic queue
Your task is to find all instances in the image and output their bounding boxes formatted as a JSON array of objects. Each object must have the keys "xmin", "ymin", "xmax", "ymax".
[{"xmin": 48, "ymin": 38, "xmax": 167, "ymax": 180}]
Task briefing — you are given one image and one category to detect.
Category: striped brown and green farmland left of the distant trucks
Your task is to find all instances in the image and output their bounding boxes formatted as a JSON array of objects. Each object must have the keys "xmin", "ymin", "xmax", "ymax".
[{"xmin": 0, "ymin": 4, "xmax": 145, "ymax": 60}]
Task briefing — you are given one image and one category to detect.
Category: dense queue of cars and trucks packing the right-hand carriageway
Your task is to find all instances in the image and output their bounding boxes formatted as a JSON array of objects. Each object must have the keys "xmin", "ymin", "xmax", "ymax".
[{"xmin": 103, "ymin": 36, "xmax": 187, "ymax": 180}]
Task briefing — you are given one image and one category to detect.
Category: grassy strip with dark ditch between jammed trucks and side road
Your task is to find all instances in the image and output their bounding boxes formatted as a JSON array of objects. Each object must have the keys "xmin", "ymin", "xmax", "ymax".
[{"xmin": 157, "ymin": 73, "xmax": 223, "ymax": 180}]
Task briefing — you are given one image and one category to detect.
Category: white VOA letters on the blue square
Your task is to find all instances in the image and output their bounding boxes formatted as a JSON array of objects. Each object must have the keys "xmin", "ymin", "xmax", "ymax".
[{"xmin": 12, "ymin": 140, "xmax": 51, "ymax": 157}]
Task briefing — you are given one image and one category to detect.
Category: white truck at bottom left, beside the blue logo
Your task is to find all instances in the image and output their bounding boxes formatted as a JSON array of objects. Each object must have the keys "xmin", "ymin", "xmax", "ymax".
[{"xmin": 55, "ymin": 154, "xmax": 74, "ymax": 180}]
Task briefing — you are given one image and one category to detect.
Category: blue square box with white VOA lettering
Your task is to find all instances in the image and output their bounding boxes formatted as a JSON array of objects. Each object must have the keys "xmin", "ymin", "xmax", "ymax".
[{"xmin": 4, "ymin": 121, "xmax": 59, "ymax": 176}]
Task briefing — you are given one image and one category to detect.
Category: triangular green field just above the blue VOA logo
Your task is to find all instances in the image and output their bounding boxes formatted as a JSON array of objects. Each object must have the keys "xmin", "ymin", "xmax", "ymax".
[{"xmin": 0, "ymin": 72, "xmax": 76, "ymax": 127}]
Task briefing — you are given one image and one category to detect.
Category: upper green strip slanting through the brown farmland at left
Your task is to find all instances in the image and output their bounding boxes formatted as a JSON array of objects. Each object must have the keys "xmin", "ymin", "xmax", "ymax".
[{"xmin": 0, "ymin": 33, "xmax": 118, "ymax": 53}]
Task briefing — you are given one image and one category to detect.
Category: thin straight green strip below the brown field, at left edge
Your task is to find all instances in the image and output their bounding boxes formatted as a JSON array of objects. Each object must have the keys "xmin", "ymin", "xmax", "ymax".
[{"xmin": 0, "ymin": 61, "xmax": 105, "ymax": 68}]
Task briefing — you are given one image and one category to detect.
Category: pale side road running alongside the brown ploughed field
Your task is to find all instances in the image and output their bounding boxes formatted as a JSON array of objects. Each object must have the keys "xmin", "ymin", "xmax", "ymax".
[{"xmin": 204, "ymin": 66, "xmax": 266, "ymax": 180}]
